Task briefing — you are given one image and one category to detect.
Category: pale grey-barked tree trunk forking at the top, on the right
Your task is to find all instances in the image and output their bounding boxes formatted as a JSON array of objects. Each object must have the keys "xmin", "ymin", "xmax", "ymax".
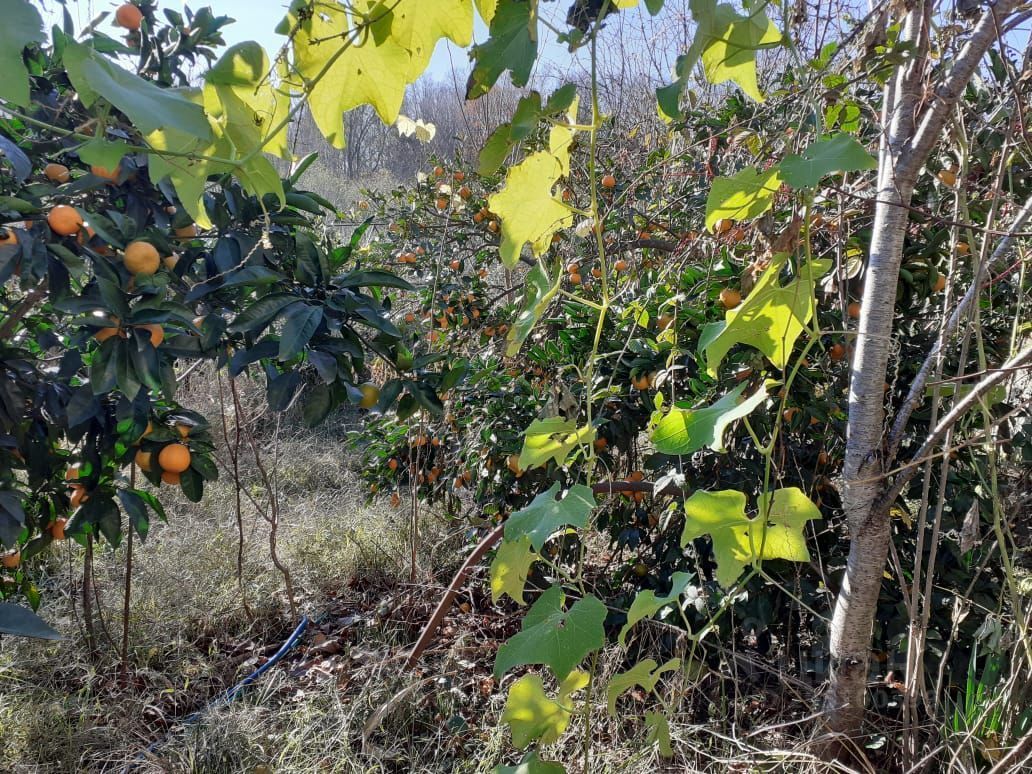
[{"xmin": 825, "ymin": 0, "xmax": 1015, "ymax": 754}]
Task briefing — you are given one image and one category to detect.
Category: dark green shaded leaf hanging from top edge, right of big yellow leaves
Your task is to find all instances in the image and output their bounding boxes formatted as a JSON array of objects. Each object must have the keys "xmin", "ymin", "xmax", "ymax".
[{"xmin": 465, "ymin": 0, "xmax": 538, "ymax": 99}]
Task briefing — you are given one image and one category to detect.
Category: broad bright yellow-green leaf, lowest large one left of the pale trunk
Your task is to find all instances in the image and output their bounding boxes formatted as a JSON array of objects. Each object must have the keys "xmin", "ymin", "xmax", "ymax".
[{"xmin": 681, "ymin": 487, "xmax": 820, "ymax": 587}]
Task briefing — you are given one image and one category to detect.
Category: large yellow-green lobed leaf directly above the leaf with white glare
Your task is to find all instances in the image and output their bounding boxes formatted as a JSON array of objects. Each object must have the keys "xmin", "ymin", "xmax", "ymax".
[{"xmin": 699, "ymin": 253, "xmax": 832, "ymax": 377}]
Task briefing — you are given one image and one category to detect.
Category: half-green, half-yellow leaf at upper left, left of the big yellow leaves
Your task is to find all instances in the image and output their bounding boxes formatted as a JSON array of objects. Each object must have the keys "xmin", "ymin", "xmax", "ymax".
[{"xmin": 204, "ymin": 41, "xmax": 290, "ymax": 158}]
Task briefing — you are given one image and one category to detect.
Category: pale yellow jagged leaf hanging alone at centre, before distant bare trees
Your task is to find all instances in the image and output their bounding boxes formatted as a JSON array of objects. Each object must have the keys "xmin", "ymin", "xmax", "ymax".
[{"xmin": 487, "ymin": 151, "xmax": 574, "ymax": 268}]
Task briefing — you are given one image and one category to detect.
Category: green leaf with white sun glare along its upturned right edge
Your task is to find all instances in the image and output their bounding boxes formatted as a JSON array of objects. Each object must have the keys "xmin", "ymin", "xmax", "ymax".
[{"xmin": 652, "ymin": 383, "xmax": 767, "ymax": 454}]
